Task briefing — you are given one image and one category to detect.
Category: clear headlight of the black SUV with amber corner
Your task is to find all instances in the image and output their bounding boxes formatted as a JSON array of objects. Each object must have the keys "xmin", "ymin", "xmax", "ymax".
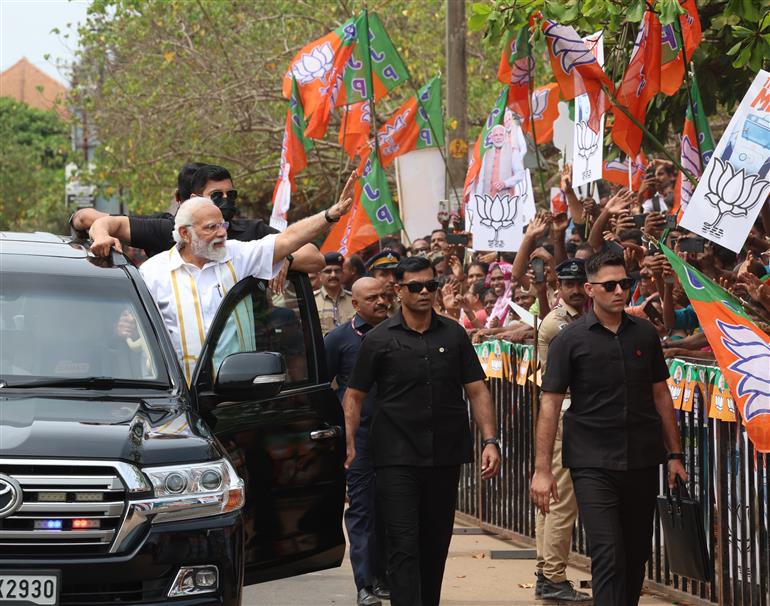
[{"xmin": 139, "ymin": 459, "xmax": 245, "ymax": 522}]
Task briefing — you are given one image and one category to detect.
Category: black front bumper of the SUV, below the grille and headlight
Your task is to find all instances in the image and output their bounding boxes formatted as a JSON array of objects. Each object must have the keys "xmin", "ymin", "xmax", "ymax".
[{"xmin": 0, "ymin": 512, "xmax": 243, "ymax": 606}]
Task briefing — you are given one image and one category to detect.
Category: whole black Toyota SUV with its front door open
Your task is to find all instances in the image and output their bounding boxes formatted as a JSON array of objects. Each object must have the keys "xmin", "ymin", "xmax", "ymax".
[{"xmin": 0, "ymin": 233, "xmax": 345, "ymax": 606}]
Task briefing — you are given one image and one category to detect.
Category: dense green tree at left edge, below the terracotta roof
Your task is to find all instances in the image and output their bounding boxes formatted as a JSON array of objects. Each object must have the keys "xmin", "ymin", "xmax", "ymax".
[{"xmin": 0, "ymin": 97, "xmax": 69, "ymax": 233}]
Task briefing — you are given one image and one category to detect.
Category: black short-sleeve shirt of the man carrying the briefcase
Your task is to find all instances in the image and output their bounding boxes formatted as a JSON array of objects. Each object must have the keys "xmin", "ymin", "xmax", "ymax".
[{"xmin": 542, "ymin": 311, "xmax": 668, "ymax": 470}]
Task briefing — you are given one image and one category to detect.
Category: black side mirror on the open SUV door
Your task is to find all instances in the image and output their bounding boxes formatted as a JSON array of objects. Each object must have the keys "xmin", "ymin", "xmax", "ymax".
[{"xmin": 214, "ymin": 351, "xmax": 286, "ymax": 400}]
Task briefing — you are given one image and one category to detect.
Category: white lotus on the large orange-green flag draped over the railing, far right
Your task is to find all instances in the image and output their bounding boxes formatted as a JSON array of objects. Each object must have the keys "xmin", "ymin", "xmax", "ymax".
[{"xmin": 717, "ymin": 320, "xmax": 770, "ymax": 422}]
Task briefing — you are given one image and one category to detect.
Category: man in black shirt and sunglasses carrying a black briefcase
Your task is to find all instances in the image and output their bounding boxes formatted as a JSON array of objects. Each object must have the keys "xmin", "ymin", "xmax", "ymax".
[{"xmin": 531, "ymin": 251, "xmax": 687, "ymax": 606}]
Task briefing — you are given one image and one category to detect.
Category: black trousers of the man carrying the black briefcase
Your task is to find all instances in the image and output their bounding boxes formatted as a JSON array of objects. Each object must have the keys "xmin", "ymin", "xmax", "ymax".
[{"xmin": 570, "ymin": 466, "xmax": 660, "ymax": 606}]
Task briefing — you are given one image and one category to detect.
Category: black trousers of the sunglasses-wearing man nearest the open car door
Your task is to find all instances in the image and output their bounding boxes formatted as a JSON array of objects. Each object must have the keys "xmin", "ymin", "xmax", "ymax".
[{"xmin": 376, "ymin": 465, "xmax": 460, "ymax": 606}]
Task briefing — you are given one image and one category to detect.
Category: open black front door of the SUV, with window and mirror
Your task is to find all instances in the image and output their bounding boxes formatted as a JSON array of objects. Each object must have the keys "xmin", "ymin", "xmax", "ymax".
[{"xmin": 191, "ymin": 273, "xmax": 345, "ymax": 584}]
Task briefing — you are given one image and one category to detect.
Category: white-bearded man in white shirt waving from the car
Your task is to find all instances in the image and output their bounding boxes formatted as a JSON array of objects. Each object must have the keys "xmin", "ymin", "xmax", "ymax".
[{"xmin": 139, "ymin": 176, "xmax": 355, "ymax": 381}]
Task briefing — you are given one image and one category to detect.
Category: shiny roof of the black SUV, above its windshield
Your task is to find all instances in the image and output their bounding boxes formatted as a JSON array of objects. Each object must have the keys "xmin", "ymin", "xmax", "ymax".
[{"xmin": 0, "ymin": 232, "xmax": 126, "ymax": 279}]
